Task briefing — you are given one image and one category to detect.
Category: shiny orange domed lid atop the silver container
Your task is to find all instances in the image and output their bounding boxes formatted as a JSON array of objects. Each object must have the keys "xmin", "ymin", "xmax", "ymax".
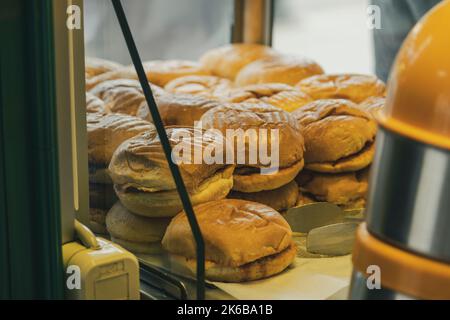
[{"xmin": 379, "ymin": 0, "xmax": 450, "ymax": 149}]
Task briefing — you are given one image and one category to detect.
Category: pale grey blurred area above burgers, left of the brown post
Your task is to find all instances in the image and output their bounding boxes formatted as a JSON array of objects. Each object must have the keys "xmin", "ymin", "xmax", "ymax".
[{"xmin": 84, "ymin": 0, "xmax": 233, "ymax": 64}]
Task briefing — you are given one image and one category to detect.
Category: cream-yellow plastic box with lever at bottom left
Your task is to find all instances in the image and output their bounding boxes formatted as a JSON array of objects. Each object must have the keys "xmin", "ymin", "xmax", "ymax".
[{"xmin": 63, "ymin": 220, "xmax": 139, "ymax": 300}]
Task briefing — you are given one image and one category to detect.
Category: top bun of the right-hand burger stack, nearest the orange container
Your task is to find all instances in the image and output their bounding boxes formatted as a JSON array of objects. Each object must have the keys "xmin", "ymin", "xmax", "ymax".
[{"xmin": 291, "ymin": 99, "xmax": 377, "ymax": 170}]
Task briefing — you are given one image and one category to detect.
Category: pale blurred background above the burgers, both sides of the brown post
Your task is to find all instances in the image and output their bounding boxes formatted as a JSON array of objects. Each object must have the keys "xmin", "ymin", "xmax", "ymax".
[{"xmin": 84, "ymin": 0, "xmax": 373, "ymax": 73}]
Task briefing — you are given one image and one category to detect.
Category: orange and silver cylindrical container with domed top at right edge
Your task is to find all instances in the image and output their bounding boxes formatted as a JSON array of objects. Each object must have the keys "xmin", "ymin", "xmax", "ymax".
[{"xmin": 350, "ymin": 0, "xmax": 450, "ymax": 299}]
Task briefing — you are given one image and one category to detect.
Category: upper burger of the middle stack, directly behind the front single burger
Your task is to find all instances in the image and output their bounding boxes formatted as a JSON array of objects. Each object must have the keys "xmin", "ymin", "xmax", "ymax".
[{"xmin": 201, "ymin": 102, "xmax": 304, "ymax": 192}]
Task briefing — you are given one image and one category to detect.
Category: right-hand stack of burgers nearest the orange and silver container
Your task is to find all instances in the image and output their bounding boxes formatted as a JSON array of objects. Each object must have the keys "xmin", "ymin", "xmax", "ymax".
[{"xmin": 292, "ymin": 75, "xmax": 385, "ymax": 209}]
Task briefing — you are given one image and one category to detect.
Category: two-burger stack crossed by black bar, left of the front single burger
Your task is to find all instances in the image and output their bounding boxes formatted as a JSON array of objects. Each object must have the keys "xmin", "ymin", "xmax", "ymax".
[{"xmin": 106, "ymin": 126, "xmax": 234, "ymax": 254}]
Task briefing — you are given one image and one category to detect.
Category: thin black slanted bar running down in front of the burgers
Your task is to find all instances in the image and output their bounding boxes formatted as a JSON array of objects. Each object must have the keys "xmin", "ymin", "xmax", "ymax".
[{"xmin": 111, "ymin": 0, "xmax": 205, "ymax": 300}]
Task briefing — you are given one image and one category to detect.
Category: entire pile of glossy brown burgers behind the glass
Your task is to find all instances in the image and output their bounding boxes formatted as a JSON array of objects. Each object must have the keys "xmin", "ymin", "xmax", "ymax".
[{"xmin": 86, "ymin": 44, "xmax": 384, "ymax": 282}]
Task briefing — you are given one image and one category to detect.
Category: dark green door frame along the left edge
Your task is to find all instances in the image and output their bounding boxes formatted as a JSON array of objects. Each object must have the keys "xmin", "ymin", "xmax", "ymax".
[{"xmin": 0, "ymin": 0, "xmax": 63, "ymax": 299}]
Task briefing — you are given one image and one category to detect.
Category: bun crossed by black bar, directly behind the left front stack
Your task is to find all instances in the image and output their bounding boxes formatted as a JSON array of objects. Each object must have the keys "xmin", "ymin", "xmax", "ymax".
[{"xmin": 136, "ymin": 93, "xmax": 221, "ymax": 126}]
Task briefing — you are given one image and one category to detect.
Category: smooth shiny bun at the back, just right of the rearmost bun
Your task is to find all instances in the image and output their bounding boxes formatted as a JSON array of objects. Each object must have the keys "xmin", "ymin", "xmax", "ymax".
[{"xmin": 236, "ymin": 55, "xmax": 323, "ymax": 86}]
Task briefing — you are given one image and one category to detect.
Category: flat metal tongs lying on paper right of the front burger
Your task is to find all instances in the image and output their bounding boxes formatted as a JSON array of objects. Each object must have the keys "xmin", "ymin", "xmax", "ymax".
[{"xmin": 284, "ymin": 202, "xmax": 364, "ymax": 256}]
